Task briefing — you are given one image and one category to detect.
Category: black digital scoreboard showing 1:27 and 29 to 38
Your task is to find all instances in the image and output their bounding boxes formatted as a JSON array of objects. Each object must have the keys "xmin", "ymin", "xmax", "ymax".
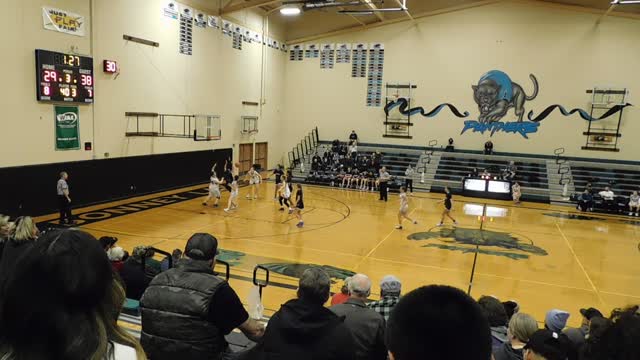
[{"xmin": 36, "ymin": 50, "xmax": 94, "ymax": 104}]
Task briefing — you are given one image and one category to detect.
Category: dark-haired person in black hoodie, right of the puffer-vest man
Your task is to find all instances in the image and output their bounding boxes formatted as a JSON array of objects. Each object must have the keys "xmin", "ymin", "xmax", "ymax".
[{"xmin": 238, "ymin": 267, "xmax": 355, "ymax": 360}]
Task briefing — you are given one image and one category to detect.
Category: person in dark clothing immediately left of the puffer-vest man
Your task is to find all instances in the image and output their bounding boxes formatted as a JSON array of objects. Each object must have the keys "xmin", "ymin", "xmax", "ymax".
[{"xmin": 120, "ymin": 246, "xmax": 160, "ymax": 300}]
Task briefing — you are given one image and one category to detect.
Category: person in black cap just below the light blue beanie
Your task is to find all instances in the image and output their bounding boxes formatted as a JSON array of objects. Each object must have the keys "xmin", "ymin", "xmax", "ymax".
[{"xmin": 524, "ymin": 329, "xmax": 572, "ymax": 360}]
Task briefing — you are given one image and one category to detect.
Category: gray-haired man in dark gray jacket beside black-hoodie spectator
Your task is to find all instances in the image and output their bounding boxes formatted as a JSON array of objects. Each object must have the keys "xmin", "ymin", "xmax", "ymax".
[{"xmin": 330, "ymin": 274, "xmax": 387, "ymax": 360}]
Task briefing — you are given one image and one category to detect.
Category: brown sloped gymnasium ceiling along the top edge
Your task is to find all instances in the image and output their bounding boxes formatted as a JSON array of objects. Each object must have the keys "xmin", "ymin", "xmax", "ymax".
[{"xmin": 209, "ymin": 0, "xmax": 640, "ymax": 41}]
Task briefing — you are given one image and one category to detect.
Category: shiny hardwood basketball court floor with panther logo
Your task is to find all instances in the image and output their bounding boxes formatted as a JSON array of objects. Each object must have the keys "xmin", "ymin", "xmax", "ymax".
[{"xmin": 39, "ymin": 183, "xmax": 640, "ymax": 326}]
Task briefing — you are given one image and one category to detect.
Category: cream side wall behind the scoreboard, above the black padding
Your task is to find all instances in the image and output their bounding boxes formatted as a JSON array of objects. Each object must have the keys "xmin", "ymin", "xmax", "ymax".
[{"xmin": 0, "ymin": 0, "xmax": 286, "ymax": 167}]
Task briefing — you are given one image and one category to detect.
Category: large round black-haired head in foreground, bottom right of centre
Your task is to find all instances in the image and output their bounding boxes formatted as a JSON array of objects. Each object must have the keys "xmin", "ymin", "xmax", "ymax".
[{"xmin": 386, "ymin": 285, "xmax": 491, "ymax": 360}]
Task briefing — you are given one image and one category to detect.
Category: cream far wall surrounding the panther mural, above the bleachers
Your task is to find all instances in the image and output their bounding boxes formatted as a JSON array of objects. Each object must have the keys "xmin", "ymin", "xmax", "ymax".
[{"xmin": 284, "ymin": 1, "xmax": 640, "ymax": 160}]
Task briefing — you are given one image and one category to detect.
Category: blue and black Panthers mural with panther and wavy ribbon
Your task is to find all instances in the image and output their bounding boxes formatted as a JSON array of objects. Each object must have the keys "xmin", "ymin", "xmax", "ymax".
[{"xmin": 384, "ymin": 70, "xmax": 631, "ymax": 139}]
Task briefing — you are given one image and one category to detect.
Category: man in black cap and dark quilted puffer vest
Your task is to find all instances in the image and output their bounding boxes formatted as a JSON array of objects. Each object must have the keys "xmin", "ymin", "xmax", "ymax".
[{"xmin": 140, "ymin": 233, "xmax": 264, "ymax": 360}]
